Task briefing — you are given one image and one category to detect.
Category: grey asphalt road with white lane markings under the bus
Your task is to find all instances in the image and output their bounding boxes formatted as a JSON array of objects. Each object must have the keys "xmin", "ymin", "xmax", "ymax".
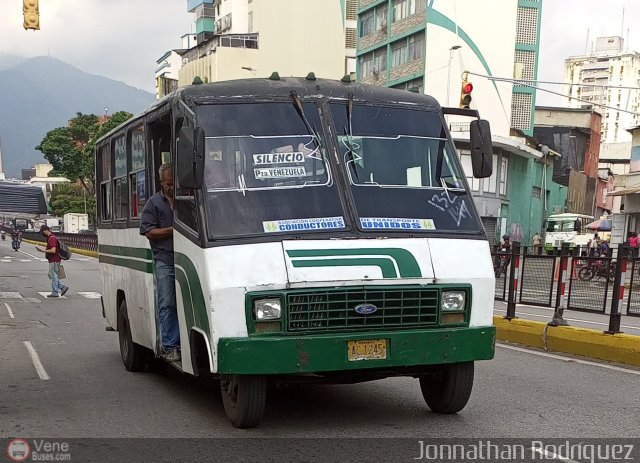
[{"xmin": 0, "ymin": 242, "xmax": 640, "ymax": 461}]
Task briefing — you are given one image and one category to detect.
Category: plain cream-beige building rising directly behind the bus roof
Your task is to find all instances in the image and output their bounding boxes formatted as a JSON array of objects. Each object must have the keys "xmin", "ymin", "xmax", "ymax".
[{"xmin": 178, "ymin": 0, "xmax": 355, "ymax": 86}]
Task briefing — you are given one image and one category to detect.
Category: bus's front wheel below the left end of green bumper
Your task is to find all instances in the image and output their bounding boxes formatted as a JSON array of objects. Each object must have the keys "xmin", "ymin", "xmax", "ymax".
[{"xmin": 220, "ymin": 375, "xmax": 267, "ymax": 429}]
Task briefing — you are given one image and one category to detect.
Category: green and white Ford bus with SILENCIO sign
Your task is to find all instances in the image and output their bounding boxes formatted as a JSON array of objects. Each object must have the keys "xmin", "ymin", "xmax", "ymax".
[{"xmin": 96, "ymin": 74, "xmax": 495, "ymax": 428}]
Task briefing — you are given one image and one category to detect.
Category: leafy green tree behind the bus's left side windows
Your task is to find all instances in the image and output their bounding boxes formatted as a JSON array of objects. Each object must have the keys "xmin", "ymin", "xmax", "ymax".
[{"xmin": 36, "ymin": 111, "xmax": 132, "ymax": 196}]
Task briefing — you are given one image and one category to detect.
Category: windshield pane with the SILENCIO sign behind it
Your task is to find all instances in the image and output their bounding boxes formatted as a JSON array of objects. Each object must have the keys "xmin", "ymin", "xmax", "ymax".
[{"xmin": 196, "ymin": 103, "xmax": 345, "ymax": 239}]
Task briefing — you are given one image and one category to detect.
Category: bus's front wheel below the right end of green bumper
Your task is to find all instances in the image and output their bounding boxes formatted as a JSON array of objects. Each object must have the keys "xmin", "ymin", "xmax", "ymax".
[{"xmin": 420, "ymin": 362, "xmax": 474, "ymax": 414}]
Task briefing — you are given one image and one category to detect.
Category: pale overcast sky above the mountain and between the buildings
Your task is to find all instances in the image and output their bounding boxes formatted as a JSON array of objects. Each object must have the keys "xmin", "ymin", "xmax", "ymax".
[{"xmin": 0, "ymin": 0, "xmax": 640, "ymax": 99}]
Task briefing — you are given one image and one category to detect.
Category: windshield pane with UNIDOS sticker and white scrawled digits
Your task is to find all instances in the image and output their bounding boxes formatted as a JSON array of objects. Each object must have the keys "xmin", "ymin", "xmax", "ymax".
[{"xmin": 331, "ymin": 103, "xmax": 482, "ymax": 232}]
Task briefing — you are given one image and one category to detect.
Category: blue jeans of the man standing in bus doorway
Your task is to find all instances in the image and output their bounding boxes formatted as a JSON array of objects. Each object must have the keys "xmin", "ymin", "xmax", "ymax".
[{"xmin": 156, "ymin": 261, "xmax": 180, "ymax": 351}]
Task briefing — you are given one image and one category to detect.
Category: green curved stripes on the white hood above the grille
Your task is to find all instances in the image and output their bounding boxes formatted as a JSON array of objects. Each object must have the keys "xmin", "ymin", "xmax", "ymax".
[{"xmin": 287, "ymin": 248, "xmax": 422, "ymax": 278}]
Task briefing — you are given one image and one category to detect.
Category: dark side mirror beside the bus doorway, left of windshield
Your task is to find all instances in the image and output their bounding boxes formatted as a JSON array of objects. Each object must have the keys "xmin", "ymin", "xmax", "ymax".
[{"xmin": 177, "ymin": 127, "xmax": 204, "ymax": 190}]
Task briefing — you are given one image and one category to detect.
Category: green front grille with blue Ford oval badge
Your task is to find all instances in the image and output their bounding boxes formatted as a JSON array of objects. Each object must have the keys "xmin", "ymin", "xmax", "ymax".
[{"xmin": 287, "ymin": 288, "xmax": 439, "ymax": 333}]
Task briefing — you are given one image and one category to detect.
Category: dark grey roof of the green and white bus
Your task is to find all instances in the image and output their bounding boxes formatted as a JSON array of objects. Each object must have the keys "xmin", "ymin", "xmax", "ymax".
[{"xmin": 96, "ymin": 77, "xmax": 440, "ymax": 144}]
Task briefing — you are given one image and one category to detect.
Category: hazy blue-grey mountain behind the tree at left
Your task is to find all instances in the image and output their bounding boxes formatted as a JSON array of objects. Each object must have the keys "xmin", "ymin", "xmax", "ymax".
[{"xmin": 0, "ymin": 57, "xmax": 154, "ymax": 178}]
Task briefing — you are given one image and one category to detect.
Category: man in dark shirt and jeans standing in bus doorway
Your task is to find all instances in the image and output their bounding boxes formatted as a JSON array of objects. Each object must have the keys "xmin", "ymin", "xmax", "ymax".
[{"xmin": 140, "ymin": 164, "xmax": 181, "ymax": 362}]
